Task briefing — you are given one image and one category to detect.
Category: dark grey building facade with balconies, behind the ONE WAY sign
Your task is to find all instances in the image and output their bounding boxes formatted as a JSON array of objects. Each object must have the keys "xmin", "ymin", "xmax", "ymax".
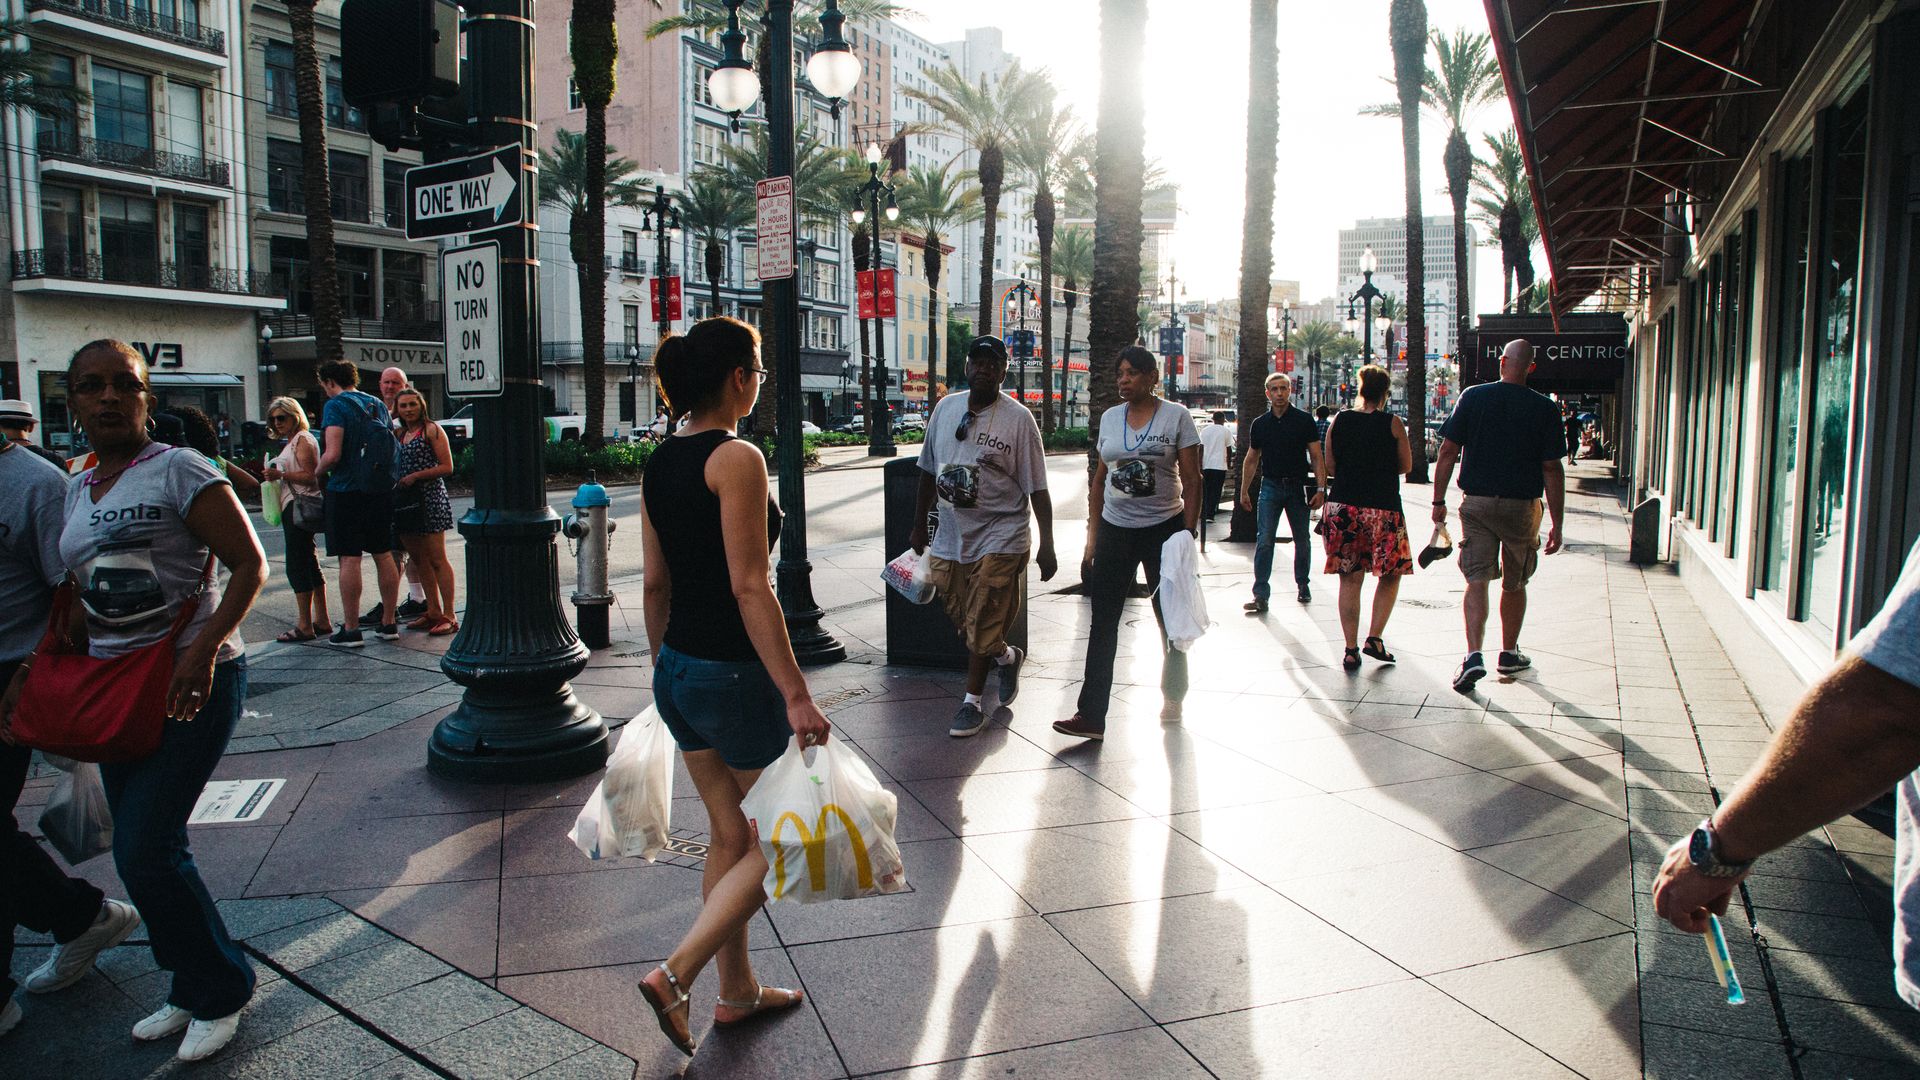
[{"xmin": 240, "ymin": 0, "xmax": 451, "ymax": 415}]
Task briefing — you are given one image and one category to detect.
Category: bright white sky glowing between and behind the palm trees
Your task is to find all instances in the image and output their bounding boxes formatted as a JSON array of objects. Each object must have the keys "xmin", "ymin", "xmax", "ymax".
[{"xmin": 900, "ymin": 0, "xmax": 1513, "ymax": 311}]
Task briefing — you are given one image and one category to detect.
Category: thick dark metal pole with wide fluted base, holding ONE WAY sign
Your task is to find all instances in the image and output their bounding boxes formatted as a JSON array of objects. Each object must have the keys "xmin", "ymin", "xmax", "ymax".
[{"xmin": 426, "ymin": 0, "xmax": 607, "ymax": 782}]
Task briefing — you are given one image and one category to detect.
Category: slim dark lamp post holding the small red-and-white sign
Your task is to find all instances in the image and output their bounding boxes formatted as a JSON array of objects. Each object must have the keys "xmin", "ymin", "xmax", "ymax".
[{"xmin": 762, "ymin": 0, "xmax": 847, "ymax": 663}]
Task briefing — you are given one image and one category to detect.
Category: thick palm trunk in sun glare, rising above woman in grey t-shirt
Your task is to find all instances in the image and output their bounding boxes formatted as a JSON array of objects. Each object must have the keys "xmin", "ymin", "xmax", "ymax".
[{"xmin": 1087, "ymin": 0, "xmax": 1146, "ymax": 417}]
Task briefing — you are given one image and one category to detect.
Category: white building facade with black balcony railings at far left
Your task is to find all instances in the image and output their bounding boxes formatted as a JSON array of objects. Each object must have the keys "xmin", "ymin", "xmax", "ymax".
[{"xmin": 0, "ymin": 0, "xmax": 284, "ymax": 452}]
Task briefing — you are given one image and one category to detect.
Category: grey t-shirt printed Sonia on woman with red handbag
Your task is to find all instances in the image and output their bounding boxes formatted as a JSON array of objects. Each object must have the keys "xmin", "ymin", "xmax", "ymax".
[{"xmin": 60, "ymin": 442, "xmax": 241, "ymax": 661}]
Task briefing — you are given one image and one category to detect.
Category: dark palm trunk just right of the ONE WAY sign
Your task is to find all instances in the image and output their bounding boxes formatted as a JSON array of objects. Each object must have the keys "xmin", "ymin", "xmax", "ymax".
[{"xmin": 568, "ymin": 0, "xmax": 614, "ymax": 450}]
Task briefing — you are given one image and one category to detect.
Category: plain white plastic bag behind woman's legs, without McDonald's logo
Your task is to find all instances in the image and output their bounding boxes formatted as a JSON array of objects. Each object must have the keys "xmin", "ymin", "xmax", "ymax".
[{"xmin": 572, "ymin": 705, "xmax": 674, "ymax": 863}]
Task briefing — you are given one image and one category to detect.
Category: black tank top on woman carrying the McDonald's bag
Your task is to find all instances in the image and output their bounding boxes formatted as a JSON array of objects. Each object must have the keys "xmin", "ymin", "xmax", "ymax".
[{"xmin": 641, "ymin": 430, "xmax": 780, "ymax": 661}]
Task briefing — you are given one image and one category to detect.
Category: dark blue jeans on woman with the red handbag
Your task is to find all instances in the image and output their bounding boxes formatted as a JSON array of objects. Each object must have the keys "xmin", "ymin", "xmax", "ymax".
[{"xmin": 100, "ymin": 657, "xmax": 253, "ymax": 1020}]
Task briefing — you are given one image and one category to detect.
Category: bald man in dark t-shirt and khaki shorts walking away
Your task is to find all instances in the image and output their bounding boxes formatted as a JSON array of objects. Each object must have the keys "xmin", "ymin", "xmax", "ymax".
[{"xmin": 1434, "ymin": 338, "xmax": 1567, "ymax": 694}]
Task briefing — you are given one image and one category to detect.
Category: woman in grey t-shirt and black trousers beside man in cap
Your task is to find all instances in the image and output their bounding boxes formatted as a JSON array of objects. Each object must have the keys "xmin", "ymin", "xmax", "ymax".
[{"xmin": 1054, "ymin": 346, "xmax": 1200, "ymax": 740}]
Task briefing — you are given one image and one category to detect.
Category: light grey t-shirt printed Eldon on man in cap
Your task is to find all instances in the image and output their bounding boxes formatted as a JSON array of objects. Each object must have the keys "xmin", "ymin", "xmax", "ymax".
[{"xmin": 920, "ymin": 392, "xmax": 1046, "ymax": 563}]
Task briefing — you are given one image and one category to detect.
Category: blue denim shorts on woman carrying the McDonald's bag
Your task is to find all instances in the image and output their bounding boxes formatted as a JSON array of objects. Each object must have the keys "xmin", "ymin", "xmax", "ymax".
[{"xmin": 653, "ymin": 646, "xmax": 793, "ymax": 769}]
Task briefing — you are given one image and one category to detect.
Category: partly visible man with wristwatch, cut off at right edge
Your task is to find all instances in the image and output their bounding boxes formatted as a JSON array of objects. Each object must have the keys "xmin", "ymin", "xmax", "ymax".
[{"xmin": 1653, "ymin": 544, "xmax": 1920, "ymax": 1009}]
